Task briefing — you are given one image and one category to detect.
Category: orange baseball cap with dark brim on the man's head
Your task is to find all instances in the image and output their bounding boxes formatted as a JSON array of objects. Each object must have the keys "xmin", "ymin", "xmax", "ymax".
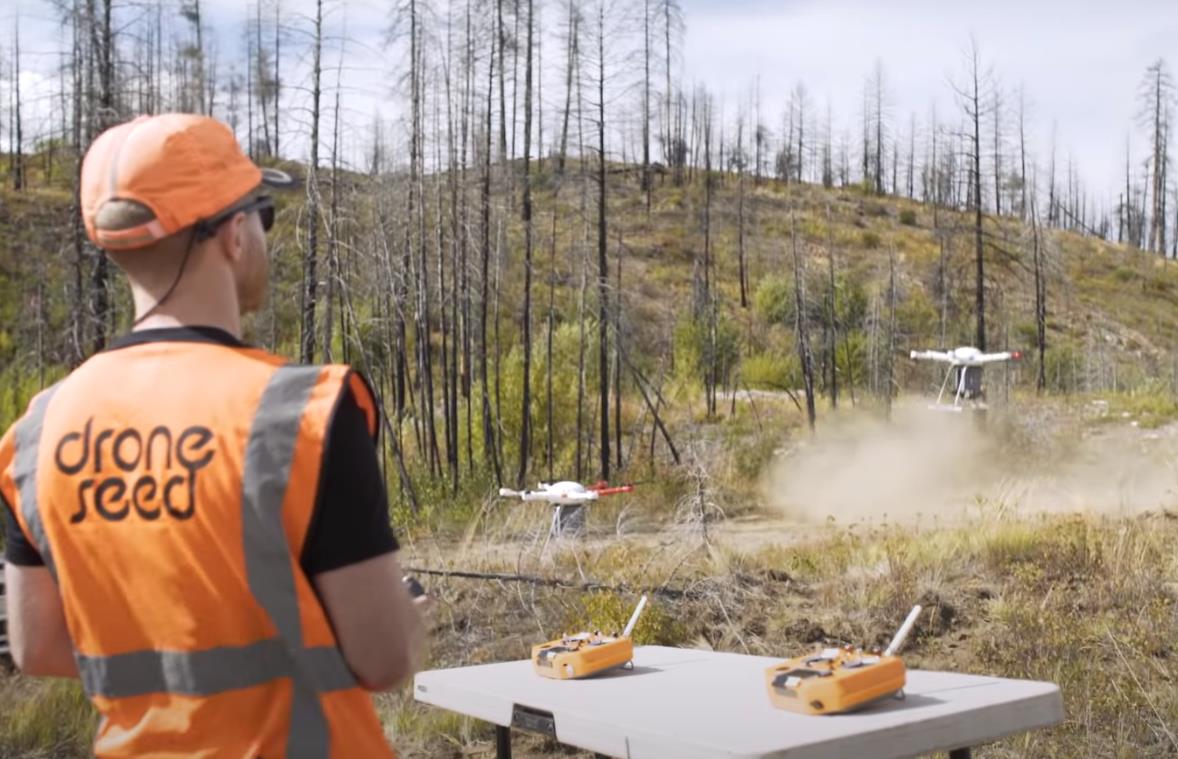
[{"xmin": 81, "ymin": 113, "xmax": 292, "ymax": 250}]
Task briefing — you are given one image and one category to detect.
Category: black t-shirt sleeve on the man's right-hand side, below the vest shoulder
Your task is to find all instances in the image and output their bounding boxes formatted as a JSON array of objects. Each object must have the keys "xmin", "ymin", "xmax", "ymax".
[{"xmin": 300, "ymin": 384, "xmax": 398, "ymax": 576}]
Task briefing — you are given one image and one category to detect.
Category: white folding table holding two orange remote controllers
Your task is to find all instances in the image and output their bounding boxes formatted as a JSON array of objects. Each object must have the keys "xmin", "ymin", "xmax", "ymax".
[{"xmin": 413, "ymin": 646, "xmax": 1064, "ymax": 759}]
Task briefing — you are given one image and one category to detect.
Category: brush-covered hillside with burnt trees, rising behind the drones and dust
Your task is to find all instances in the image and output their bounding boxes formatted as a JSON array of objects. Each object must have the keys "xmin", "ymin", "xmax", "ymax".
[{"xmin": 0, "ymin": 161, "xmax": 1178, "ymax": 529}]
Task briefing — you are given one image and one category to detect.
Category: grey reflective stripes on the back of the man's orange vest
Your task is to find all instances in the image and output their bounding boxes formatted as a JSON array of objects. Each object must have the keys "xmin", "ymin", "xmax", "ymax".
[{"xmin": 14, "ymin": 365, "xmax": 357, "ymax": 758}]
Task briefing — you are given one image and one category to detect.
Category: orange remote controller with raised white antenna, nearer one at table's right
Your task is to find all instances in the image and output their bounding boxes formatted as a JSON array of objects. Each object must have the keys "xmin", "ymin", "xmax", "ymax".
[{"xmin": 765, "ymin": 606, "xmax": 920, "ymax": 714}]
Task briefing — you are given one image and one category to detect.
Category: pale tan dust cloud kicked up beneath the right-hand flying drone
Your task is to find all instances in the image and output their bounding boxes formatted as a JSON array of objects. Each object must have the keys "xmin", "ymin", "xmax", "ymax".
[{"xmin": 762, "ymin": 401, "xmax": 1178, "ymax": 523}]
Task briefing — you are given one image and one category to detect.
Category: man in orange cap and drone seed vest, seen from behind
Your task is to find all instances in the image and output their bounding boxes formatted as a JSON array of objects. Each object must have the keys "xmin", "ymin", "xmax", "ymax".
[{"xmin": 0, "ymin": 114, "xmax": 424, "ymax": 759}]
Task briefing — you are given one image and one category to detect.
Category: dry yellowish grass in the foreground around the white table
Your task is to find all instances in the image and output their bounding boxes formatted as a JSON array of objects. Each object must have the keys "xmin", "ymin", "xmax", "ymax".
[{"xmin": 0, "ymin": 417, "xmax": 1178, "ymax": 758}]
